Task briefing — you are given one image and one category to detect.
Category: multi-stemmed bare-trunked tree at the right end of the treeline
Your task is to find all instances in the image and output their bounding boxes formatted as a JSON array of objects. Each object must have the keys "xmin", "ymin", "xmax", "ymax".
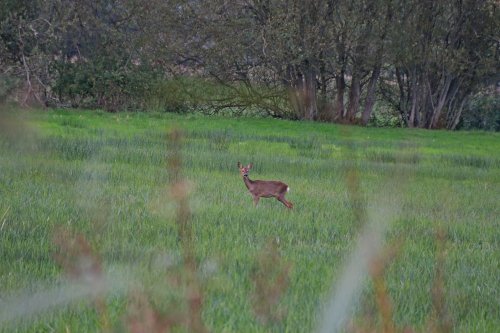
[{"xmin": 390, "ymin": 1, "xmax": 499, "ymax": 129}]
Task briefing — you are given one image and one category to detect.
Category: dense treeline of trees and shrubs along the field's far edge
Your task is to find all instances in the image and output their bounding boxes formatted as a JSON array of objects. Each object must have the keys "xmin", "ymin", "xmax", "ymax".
[{"xmin": 0, "ymin": 0, "xmax": 500, "ymax": 130}]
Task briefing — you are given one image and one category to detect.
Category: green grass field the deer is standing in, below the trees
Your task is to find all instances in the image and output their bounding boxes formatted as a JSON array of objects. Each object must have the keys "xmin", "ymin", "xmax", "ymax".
[{"xmin": 0, "ymin": 110, "xmax": 500, "ymax": 332}]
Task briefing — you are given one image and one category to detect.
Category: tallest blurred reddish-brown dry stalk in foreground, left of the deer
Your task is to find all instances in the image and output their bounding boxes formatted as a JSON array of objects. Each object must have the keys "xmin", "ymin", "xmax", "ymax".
[{"xmin": 126, "ymin": 129, "xmax": 207, "ymax": 333}]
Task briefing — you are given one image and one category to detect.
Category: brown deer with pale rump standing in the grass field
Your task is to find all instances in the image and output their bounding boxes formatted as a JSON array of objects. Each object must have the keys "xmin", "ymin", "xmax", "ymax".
[{"xmin": 238, "ymin": 162, "xmax": 293, "ymax": 209}]
